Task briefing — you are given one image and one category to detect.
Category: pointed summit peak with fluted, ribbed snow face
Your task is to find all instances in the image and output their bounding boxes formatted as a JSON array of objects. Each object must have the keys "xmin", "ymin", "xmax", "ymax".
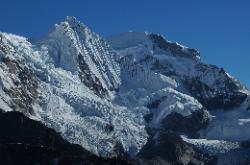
[{"xmin": 40, "ymin": 17, "xmax": 120, "ymax": 96}]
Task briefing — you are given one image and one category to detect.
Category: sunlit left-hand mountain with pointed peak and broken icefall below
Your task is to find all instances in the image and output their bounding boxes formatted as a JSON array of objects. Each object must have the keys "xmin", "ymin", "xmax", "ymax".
[{"xmin": 0, "ymin": 17, "xmax": 147, "ymax": 157}]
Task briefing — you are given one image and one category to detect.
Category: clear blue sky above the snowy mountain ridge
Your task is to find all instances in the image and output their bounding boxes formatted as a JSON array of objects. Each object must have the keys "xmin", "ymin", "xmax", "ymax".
[{"xmin": 0, "ymin": 0, "xmax": 250, "ymax": 88}]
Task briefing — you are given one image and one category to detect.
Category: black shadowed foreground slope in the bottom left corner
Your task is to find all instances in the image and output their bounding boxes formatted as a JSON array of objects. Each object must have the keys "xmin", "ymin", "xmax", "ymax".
[{"xmin": 0, "ymin": 110, "xmax": 129, "ymax": 165}]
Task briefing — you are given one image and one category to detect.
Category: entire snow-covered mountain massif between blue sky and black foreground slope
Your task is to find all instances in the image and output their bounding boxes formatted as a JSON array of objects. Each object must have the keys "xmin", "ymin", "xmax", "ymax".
[{"xmin": 0, "ymin": 17, "xmax": 250, "ymax": 164}]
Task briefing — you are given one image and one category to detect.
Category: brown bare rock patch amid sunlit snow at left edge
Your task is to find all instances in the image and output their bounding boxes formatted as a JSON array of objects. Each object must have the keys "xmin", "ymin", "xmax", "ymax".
[{"xmin": 2, "ymin": 57, "xmax": 39, "ymax": 114}]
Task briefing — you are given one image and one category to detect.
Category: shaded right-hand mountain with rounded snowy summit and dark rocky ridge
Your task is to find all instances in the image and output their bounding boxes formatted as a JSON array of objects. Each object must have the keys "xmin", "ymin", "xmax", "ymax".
[{"xmin": 107, "ymin": 32, "xmax": 250, "ymax": 164}]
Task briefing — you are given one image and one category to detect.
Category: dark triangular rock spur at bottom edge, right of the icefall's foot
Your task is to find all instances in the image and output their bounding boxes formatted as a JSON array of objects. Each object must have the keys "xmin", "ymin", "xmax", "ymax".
[{"xmin": 136, "ymin": 129, "xmax": 216, "ymax": 165}]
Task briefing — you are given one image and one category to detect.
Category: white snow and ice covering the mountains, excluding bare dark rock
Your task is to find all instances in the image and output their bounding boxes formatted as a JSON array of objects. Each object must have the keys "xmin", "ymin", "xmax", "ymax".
[{"xmin": 0, "ymin": 17, "xmax": 250, "ymax": 161}]
